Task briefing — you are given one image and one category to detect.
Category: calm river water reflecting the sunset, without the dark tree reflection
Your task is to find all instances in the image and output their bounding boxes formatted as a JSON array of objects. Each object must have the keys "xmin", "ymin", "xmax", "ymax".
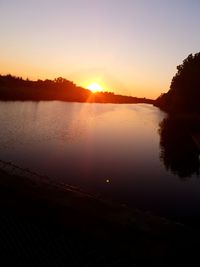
[{"xmin": 0, "ymin": 101, "xmax": 200, "ymax": 223}]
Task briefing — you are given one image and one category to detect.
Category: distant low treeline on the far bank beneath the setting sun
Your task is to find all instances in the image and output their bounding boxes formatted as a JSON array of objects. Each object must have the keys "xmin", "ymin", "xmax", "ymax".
[{"xmin": 0, "ymin": 75, "xmax": 153, "ymax": 103}]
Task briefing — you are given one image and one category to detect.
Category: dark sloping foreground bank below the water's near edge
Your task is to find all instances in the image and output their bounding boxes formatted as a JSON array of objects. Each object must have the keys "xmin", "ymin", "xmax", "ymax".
[{"xmin": 0, "ymin": 171, "xmax": 200, "ymax": 267}]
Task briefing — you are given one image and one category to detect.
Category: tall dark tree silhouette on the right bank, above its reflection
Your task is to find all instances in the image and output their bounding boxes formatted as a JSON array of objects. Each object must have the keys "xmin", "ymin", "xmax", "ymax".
[{"xmin": 155, "ymin": 53, "xmax": 200, "ymax": 114}]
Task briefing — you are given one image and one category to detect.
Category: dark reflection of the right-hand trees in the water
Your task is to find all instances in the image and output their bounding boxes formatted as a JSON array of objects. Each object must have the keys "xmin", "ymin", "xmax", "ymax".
[{"xmin": 159, "ymin": 116, "xmax": 200, "ymax": 178}]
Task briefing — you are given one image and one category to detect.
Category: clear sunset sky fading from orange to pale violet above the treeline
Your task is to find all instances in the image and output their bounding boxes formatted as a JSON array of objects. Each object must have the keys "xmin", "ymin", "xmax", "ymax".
[{"xmin": 0, "ymin": 0, "xmax": 200, "ymax": 98}]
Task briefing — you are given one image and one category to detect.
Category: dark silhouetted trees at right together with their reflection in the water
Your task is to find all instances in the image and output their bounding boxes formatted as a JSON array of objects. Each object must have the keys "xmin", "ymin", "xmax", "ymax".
[{"xmin": 154, "ymin": 53, "xmax": 200, "ymax": 179}]
